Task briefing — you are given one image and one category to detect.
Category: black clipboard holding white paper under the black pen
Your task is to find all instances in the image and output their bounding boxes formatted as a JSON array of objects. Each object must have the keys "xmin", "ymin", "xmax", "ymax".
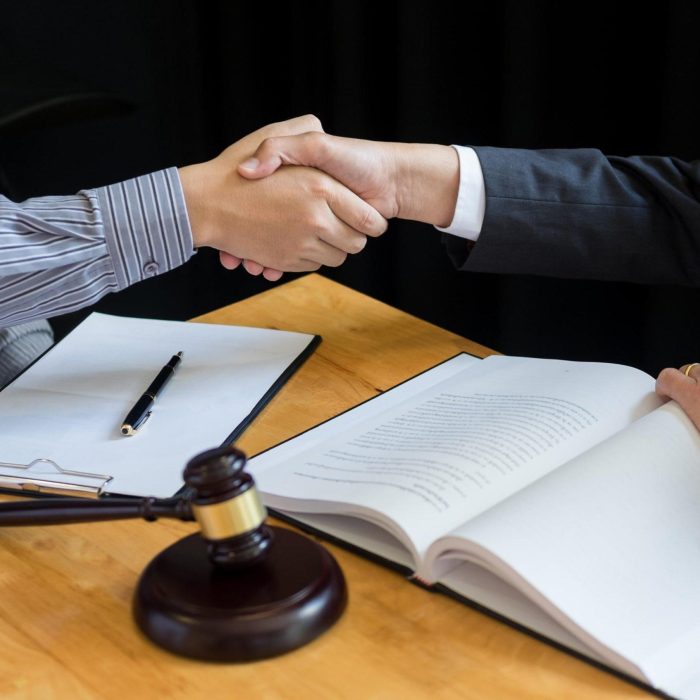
[{"xmin": 0, "ymin": 313, "xmax": 321, "ymax": 498}]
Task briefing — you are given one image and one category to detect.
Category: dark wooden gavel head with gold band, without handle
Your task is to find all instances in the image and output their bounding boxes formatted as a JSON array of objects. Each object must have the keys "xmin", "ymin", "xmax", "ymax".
[{"xmin": 184, "ymin": 447, "xmax": 272, "ymax": 569}]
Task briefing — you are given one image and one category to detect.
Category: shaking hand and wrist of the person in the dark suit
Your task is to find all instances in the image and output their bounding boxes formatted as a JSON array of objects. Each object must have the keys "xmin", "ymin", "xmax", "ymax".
[{"xmin": 238, "ymin": 130, "xmax": 459, "ymax": 226}]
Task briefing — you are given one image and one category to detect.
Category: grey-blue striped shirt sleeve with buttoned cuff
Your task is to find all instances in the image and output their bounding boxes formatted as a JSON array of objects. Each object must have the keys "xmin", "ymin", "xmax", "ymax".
[{"xmin": 0, "ymin": 168, "xmax": 194, "ymax": 326}]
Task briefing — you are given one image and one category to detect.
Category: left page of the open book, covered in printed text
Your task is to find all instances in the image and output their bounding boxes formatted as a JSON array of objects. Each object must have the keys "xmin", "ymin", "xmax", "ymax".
[{"xmin": 251, "ymin": 356, "xmax": 659, "ymax": 560}]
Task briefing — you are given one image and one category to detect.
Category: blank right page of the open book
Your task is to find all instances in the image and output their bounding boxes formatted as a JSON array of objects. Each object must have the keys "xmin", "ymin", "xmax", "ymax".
[{"xmin": 431, "ymin": 403, "xmax": 700, "ymax": 697}]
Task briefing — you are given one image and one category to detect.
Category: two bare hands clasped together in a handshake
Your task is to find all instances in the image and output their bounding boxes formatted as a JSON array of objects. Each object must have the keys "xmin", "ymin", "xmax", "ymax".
[{"xmin": 179, "ymin": 115, "xmax": 459, "ymax": 281}]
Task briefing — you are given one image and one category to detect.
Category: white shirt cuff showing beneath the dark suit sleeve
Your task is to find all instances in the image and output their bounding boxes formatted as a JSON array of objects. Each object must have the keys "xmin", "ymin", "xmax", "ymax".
[{"xmin": 435, "ymin": 145, "xmax": 486, "ymax": 241}]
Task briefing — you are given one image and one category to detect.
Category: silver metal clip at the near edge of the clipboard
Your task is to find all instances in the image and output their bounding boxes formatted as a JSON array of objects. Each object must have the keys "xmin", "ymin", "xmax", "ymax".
[{"xmin": 0, "ymin": 458, "xmax": 112, "ymax": 498}]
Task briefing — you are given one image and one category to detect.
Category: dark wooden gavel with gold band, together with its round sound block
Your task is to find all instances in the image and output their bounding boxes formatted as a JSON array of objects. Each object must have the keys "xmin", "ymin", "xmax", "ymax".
[{"xmin": 0, "ymin": 446, "xmax": 347, "ymax": 661}]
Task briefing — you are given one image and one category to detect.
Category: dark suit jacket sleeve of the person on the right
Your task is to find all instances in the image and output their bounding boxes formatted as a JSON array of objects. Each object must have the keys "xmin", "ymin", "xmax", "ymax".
[{"xmin": 445, "ymin": 147, "xmax": 700, "ymax": 285}]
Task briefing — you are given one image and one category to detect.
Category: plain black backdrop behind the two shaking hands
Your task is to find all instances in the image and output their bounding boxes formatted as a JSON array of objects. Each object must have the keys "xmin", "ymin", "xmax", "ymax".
[{"xmin": 0, "ymin": 0, "xmax": 700, "ymax": 373}]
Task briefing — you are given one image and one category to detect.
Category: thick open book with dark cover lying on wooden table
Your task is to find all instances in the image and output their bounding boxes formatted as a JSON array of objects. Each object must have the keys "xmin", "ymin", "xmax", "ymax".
[{"xmin": 250, "ymin": 355, "xmax": 700, "ymax": 698}]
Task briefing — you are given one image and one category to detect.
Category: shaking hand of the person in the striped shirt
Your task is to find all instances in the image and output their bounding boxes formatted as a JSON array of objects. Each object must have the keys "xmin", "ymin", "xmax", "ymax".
[{"xmin": 180, "ymin": 116, "xmax": 386, "ymax": 276}]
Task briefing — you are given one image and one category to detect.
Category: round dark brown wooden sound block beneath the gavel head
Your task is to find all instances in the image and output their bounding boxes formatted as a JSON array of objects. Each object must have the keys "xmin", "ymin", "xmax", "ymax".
[{"xmin": 134, "ymin": 527, "xmax": 347, "ymax": 661}]
